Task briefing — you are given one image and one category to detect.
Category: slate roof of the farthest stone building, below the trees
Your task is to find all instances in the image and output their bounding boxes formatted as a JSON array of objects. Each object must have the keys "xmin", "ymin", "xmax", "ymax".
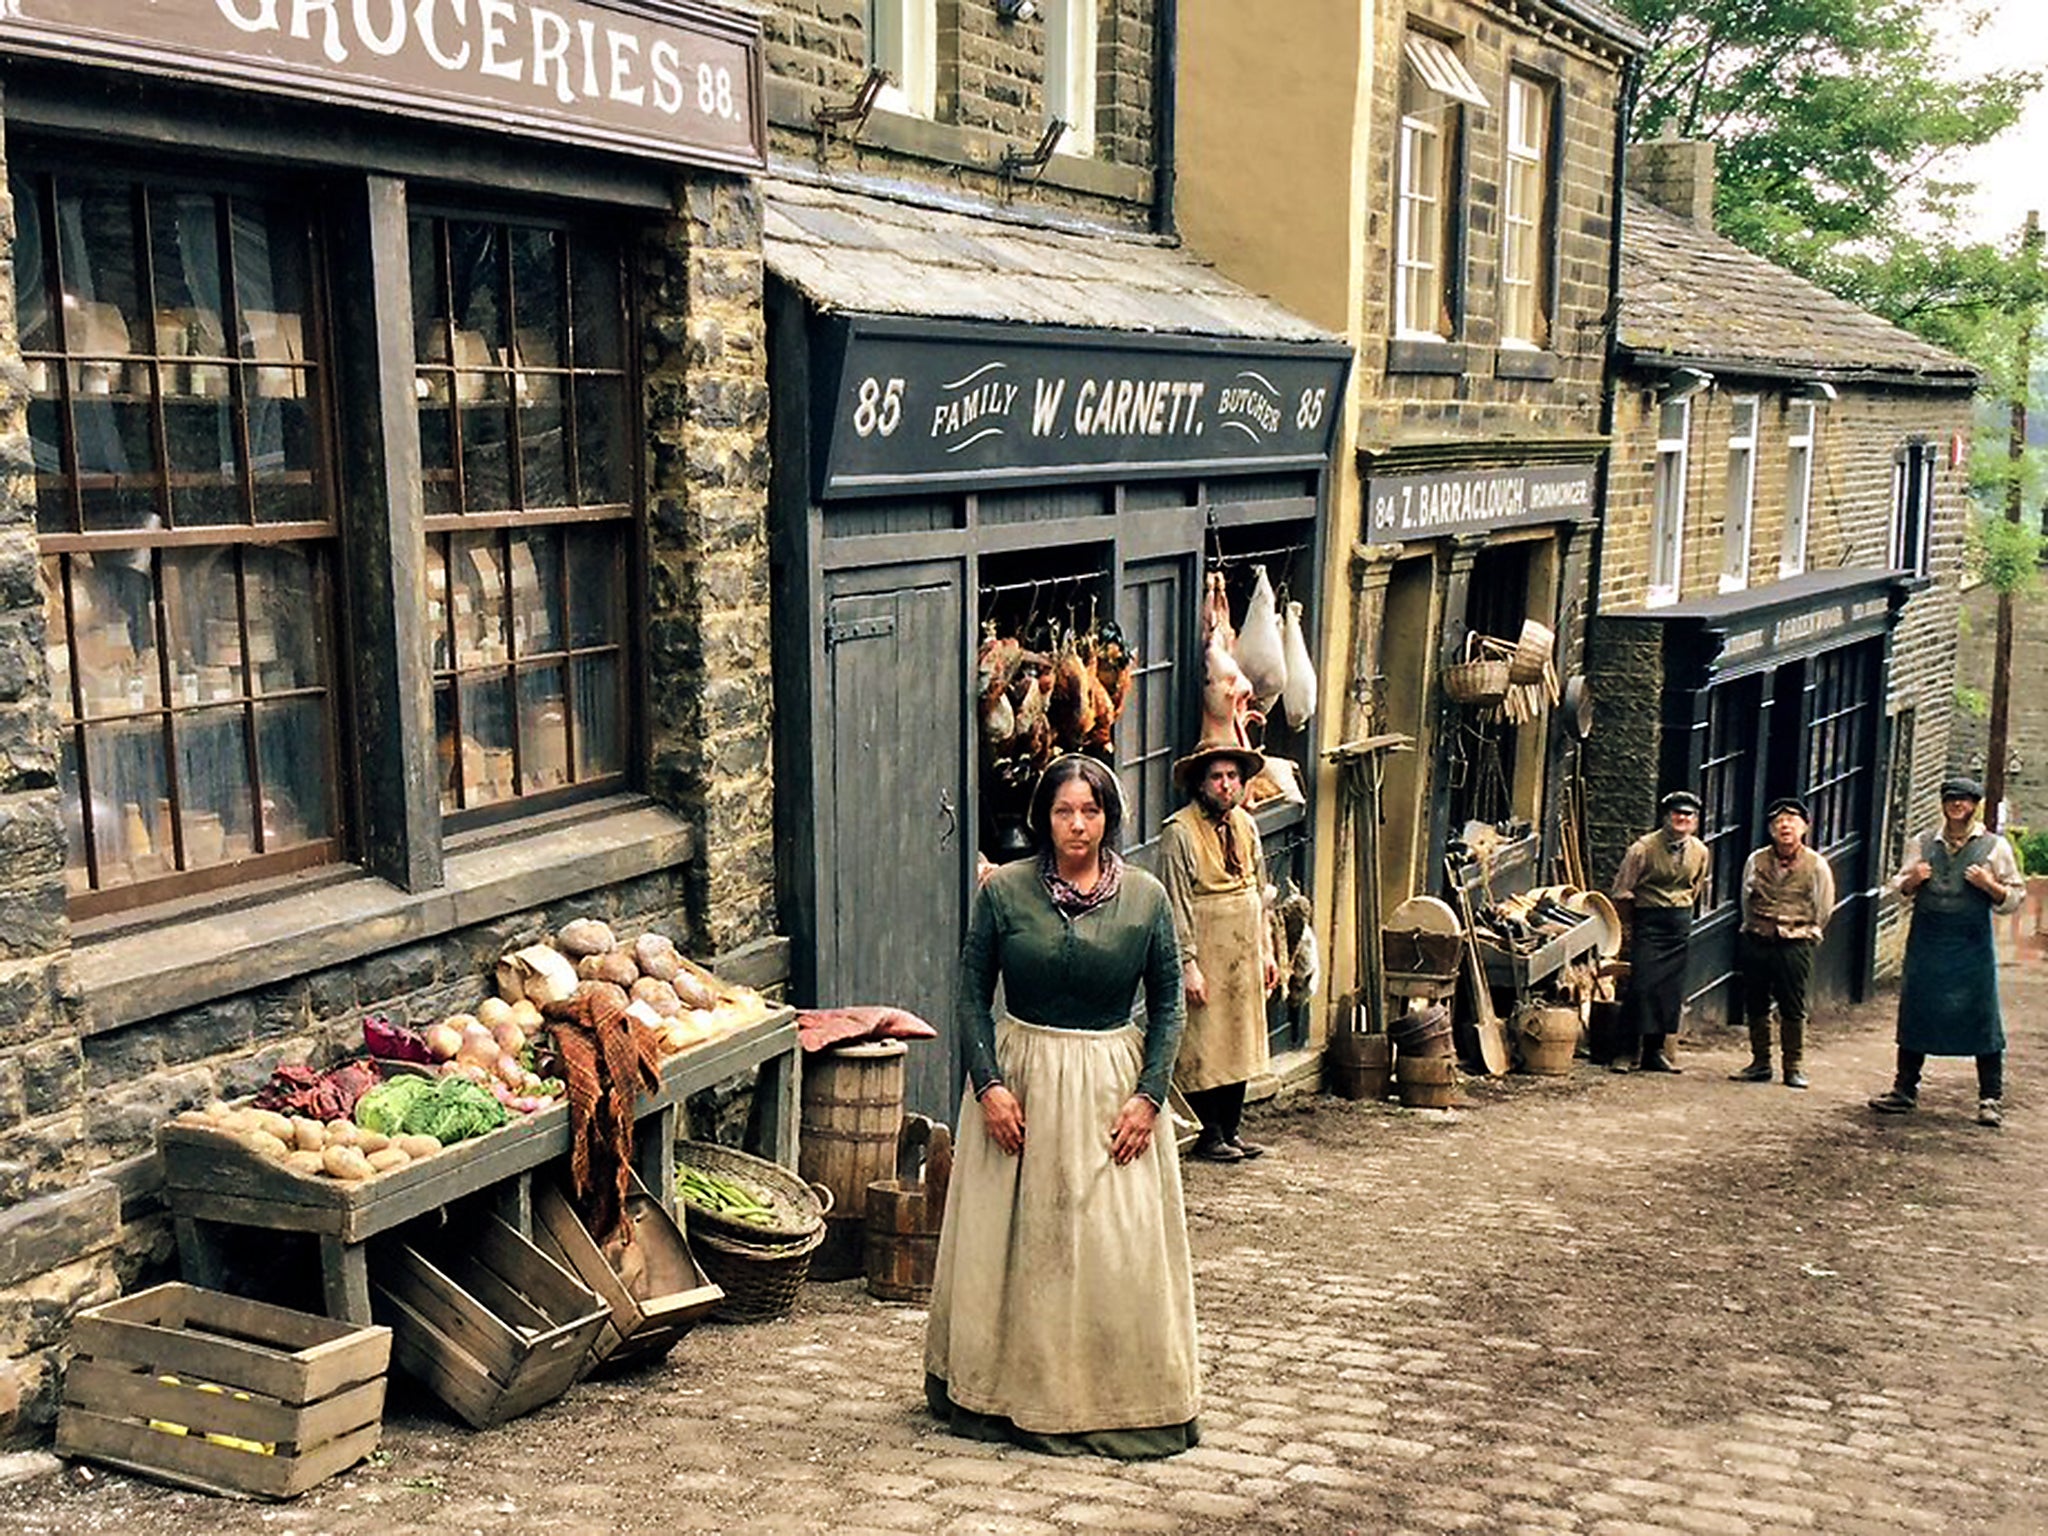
[{"xmin": 1620, "ymin": 193, "xmax": 1976, "ymax": 387}]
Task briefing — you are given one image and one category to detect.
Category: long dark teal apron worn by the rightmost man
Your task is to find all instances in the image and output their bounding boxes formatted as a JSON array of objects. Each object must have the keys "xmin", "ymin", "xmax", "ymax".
[{"xmin": 1898, "ymin": 831, "xmax": 2005, "ymax": 1057}]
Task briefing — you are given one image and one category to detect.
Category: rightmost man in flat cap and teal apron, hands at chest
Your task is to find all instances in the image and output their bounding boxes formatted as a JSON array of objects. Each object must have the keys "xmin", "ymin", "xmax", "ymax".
[{"xmin": 1870, "ymin": 778, "xmax": 2028, "ymax": 1126}]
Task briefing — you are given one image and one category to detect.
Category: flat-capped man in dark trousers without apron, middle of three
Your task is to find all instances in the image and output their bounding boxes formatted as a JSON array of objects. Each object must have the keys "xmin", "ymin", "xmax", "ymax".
[{"xmin": 1735, "ymin": 795, "xmax": 1835, "ymax": 1087}]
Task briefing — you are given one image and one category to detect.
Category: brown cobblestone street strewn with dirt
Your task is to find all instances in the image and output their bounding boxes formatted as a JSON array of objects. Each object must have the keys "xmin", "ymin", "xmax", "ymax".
[{"xmin": 0, "ymin": 961, "xmax": 2048, "ymax": 1536}]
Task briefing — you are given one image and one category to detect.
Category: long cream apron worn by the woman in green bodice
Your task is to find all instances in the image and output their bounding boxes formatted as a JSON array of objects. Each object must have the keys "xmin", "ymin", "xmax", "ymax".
[{"xmin": 924, "ymin": 1018, "xmax": 1200, "ymax": 1454}]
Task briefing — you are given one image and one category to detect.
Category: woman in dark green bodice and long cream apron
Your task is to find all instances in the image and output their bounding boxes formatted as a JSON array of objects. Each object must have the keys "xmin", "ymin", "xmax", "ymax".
[{"xmin": 924, "ymin": 756, "xmax": 1200, "ymax": 1458}]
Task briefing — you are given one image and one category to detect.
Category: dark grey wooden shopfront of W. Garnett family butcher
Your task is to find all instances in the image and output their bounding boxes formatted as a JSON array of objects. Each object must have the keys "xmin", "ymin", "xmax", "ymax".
[{"xmin": 770, "ymin": 303, "xmax": 1343, "ymax": 1118}]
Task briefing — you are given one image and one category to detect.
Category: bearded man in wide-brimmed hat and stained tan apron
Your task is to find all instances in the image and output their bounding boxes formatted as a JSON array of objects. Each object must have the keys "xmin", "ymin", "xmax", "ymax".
[{"xmin": 1159, "ymin": 739, "xmax": 1280, "ymax": 1163}]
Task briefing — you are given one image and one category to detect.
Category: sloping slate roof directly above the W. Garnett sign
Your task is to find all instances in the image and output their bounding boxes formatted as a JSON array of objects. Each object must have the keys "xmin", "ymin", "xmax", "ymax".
[{"xmin": 762, "ymin": 176, "xmax": 1341, "ymax": 342}]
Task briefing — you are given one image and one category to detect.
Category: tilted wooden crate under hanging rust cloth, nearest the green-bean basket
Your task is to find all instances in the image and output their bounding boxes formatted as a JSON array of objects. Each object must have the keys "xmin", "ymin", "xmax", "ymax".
[{"xmin": 532, "ymin": 1180, "xmax": 725, "ymax": 1368}]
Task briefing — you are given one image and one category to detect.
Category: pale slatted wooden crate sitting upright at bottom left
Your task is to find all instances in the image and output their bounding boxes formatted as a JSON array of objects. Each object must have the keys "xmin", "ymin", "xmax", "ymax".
[{"xmin": 57, "ymin": 1282, "xmax": 391, "ymax": 1499}]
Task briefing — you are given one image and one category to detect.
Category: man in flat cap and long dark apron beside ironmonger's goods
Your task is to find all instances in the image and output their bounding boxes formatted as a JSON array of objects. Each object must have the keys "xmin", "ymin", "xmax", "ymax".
[{"xmin": 1608, "ymin": 788, "xmax": 1708, "ymax": 1071}]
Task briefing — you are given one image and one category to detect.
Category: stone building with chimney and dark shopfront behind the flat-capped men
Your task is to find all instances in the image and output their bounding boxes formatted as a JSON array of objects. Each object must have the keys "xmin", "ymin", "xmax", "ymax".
[{"xmin": 1585, "ymin": 141, "xmax": 1974, "ymax": 1020}]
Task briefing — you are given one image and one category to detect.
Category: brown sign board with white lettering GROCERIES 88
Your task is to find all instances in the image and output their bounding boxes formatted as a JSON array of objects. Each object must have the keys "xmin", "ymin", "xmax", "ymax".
[{"xmin": 0, "ymin": 0, "xmax": 766, "ymax": 168}]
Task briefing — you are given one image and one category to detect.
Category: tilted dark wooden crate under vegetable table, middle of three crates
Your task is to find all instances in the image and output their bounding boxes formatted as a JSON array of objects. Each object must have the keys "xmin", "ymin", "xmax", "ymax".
[{"xmin": 371, "ymin": 1212, "xmax": 610, "ymax": 1430}]
